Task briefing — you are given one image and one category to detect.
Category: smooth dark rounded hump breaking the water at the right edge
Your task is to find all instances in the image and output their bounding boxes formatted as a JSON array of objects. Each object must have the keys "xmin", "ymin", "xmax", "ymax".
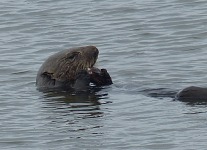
[{"xmin": 175, "ymin": 86, "xmax": 207, "ymax": 102}]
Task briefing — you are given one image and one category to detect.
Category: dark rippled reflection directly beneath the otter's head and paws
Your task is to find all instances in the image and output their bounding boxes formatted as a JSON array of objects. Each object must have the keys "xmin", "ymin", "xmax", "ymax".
[{"xmin": 38, "ymin": 87, "xmax": 109, "ymax": 122}]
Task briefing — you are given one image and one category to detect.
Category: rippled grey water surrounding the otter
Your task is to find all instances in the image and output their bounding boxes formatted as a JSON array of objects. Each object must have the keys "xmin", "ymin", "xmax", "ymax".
[{"xmin": 0, "ymin": 0, "xmax": 207, "ymax": 150}]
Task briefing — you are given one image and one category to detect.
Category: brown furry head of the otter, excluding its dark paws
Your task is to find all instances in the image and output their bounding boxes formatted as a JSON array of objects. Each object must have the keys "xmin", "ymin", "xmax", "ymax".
[{"xmin": 36, "ymin": 46, "xmax": 99, "ymax": 85}]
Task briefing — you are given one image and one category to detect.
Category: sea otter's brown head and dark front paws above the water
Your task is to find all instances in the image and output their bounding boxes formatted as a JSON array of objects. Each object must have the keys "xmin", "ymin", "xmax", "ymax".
[{"xmin": 36, "ymin": 46, "xmax": 112, "ymax": 90}]
